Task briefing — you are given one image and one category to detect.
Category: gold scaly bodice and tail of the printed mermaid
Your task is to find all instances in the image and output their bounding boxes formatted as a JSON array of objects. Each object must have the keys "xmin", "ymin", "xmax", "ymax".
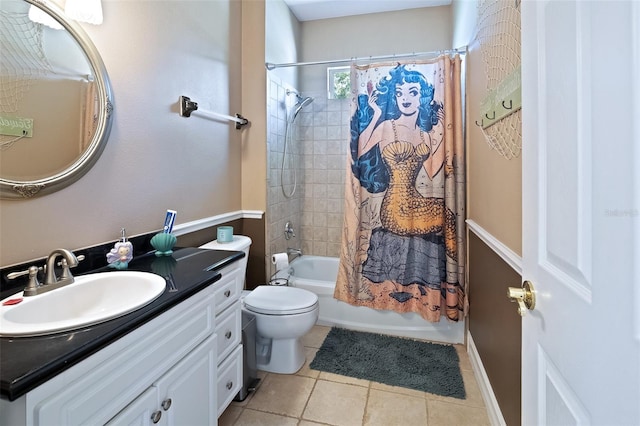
[{"xmin": 380, "ymin": 141, "xmax": 458, "ymax": 260}]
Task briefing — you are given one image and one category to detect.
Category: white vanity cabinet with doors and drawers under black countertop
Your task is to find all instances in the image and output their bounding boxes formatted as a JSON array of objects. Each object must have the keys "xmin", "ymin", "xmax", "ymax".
[{"xmin": 0, "ymin": 256, "xmax": 243, "ymax": 425}]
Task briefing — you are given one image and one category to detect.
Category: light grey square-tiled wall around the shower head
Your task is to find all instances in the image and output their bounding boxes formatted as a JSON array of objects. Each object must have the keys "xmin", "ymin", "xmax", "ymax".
[{"xmin": 267, "ymin": 77, "xmax": 349, "ymax": 276}]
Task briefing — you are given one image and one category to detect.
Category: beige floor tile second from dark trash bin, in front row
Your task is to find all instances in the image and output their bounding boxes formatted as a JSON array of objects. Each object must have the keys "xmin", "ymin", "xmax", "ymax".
[{"xmin": 302, "ymin": 380, "xmax": 368, "ymax": 426}]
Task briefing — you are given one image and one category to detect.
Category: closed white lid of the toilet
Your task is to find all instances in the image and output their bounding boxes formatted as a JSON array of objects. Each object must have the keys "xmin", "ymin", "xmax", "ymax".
[{"xmin": 244, "ymin": 285, "xmax": 318, "ymax": 315}]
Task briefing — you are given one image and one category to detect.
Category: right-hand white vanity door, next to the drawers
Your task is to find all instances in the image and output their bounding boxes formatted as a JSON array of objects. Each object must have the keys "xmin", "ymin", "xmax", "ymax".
[{"xmin": 156, "ymin": 334, "xmax": 218, "ymax": 426}]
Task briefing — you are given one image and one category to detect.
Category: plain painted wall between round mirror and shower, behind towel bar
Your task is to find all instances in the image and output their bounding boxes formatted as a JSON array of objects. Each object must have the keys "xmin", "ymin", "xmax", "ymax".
[{"xmin": 0, "ymin": 0, "xmax": 241, "ymax": 266}]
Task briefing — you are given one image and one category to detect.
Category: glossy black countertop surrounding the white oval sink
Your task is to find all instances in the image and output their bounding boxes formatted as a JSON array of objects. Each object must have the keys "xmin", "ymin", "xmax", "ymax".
[{"xmin": 0, "ymin": 248, "xmax": 245, "ymax": 401}]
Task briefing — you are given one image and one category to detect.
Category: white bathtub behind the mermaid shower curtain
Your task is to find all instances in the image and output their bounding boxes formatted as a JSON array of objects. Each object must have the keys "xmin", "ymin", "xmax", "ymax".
[{"xmin": 277, "ymin": 255, "xmax": 465, "ymax": 343}]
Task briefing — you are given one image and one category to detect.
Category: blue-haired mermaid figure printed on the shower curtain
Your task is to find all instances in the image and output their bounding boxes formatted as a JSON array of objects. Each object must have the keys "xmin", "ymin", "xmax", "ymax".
[{"xmin": 350, "ymin": 64, "xmax": 457, "ymax": 309}]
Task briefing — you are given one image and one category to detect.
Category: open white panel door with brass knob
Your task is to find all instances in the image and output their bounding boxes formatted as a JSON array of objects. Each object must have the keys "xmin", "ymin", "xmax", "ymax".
[{"xmin": 521, "ymin": 0, "xmax": 640, "ymax": 426}]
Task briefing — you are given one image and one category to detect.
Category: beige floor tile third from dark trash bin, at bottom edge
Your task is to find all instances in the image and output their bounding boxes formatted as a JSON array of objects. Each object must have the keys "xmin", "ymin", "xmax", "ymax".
[{"xmin": 363, "ymin": 389, "xmax": 427, "ymax": 426}]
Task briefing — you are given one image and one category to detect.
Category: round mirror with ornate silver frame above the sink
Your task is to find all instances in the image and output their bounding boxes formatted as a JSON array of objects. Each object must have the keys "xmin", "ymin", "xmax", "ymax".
[{"xmin": 0, "ymin": 0, "xmax": 114, "ymax": 199}]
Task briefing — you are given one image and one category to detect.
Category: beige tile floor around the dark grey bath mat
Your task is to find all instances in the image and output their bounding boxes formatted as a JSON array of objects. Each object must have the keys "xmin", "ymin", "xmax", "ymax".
[{"xmin": 218, "ymin": 326, "xmax": 490, "ymax": 426}]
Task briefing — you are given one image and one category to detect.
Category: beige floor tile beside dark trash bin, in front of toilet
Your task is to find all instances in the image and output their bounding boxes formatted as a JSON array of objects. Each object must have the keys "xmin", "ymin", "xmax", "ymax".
[{"xmin": 247, "ymin": 374, "xmax": 314, "ymax": 417}]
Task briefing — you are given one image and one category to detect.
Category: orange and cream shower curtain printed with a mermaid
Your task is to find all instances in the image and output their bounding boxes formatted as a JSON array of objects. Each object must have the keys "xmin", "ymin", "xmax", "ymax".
[{"xmin": 334, "ymin": 56, "xmax": 467, "ymax": 322}]
